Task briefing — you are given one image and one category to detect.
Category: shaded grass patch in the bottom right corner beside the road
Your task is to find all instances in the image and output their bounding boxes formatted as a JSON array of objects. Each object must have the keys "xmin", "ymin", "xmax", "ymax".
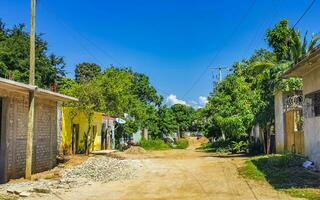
[{"xmin": 239, "ymin": 154, "xmax": 320, "ymax": 200}]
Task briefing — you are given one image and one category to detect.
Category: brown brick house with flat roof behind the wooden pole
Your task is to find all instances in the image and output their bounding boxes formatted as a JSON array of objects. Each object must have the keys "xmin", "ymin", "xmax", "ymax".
[{"xmin": 0, "ymin": 78, "xmax": 77, "ymax": 183}]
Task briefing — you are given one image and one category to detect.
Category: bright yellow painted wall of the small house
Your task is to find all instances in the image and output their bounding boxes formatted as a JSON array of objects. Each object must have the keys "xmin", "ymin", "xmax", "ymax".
[{"xmin": 62, "ymin": 107, "xmax": 103, "ymax": 152}]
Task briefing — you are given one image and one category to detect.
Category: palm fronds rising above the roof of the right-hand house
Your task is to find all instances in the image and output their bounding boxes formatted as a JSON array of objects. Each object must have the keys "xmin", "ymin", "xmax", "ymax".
[{"xmin": 289, "ymin": 30, "xmax": 320, "ymax": 63}]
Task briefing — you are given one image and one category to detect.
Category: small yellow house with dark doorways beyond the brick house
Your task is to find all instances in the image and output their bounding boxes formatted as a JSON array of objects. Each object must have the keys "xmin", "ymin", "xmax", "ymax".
[{"xmin": 61, "ymin": 107, "xmax": 114, "ymax": 154}]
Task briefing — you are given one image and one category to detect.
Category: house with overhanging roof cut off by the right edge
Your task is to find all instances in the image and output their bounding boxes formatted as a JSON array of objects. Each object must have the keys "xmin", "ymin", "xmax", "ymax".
[{"xmin": 278, "ymin": 47, "xmax": 320, "ymax": 166}]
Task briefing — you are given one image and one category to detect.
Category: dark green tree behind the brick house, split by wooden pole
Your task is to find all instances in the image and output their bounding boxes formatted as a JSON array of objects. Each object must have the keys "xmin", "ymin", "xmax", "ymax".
[{"xmin": 0, "ymin": 21, "xmax": 65, "ymax": 88}]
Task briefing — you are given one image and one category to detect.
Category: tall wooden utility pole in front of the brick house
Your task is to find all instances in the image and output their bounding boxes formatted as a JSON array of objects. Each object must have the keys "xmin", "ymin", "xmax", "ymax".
[{"xmin": 25, "ymin": 0, "xmax": 36, "ymax": 179}]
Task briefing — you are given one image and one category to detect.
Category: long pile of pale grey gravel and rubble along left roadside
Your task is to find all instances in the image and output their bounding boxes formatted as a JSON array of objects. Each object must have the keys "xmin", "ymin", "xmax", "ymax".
[{"xmin": 0, "ymin": 156, "xmax": 142, "ymax": 199}]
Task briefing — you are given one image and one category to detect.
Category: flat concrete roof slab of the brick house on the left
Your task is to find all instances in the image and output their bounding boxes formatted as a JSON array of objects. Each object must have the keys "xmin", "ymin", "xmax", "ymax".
[{"xmin": 0, "ymin": 78, "xmax": 79, "ymax": 101}]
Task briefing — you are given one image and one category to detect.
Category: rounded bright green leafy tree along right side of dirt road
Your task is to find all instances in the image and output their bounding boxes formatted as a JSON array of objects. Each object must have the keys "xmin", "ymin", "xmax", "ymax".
[{"xmin": 206, "ymin": 75, "xmax": 257, "ymax": 139}]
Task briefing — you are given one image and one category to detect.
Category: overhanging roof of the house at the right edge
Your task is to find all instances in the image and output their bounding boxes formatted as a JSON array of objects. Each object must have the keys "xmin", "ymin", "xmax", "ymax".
[{"xmin": 282, "ymin": 45, "xmax": 320, "ymax": 77}]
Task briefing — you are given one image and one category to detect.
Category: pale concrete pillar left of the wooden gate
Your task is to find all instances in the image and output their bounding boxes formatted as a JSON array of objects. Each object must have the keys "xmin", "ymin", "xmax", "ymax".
[{"xmin": 274, "ymin": 91, "xmax": 285, "ymax": 153}]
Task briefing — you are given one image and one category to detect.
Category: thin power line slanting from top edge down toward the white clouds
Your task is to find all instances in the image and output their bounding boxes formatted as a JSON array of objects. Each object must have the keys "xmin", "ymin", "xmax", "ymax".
[{"xmin": 183, "ymin": 0, "xmax": 256, "ymax": 98}]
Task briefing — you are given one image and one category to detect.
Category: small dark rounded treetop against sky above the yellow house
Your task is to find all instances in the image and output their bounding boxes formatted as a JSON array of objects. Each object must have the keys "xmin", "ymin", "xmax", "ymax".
[{"xmin": 74, "ymin": 62, "xmax": 101, "ymax": 82}]
